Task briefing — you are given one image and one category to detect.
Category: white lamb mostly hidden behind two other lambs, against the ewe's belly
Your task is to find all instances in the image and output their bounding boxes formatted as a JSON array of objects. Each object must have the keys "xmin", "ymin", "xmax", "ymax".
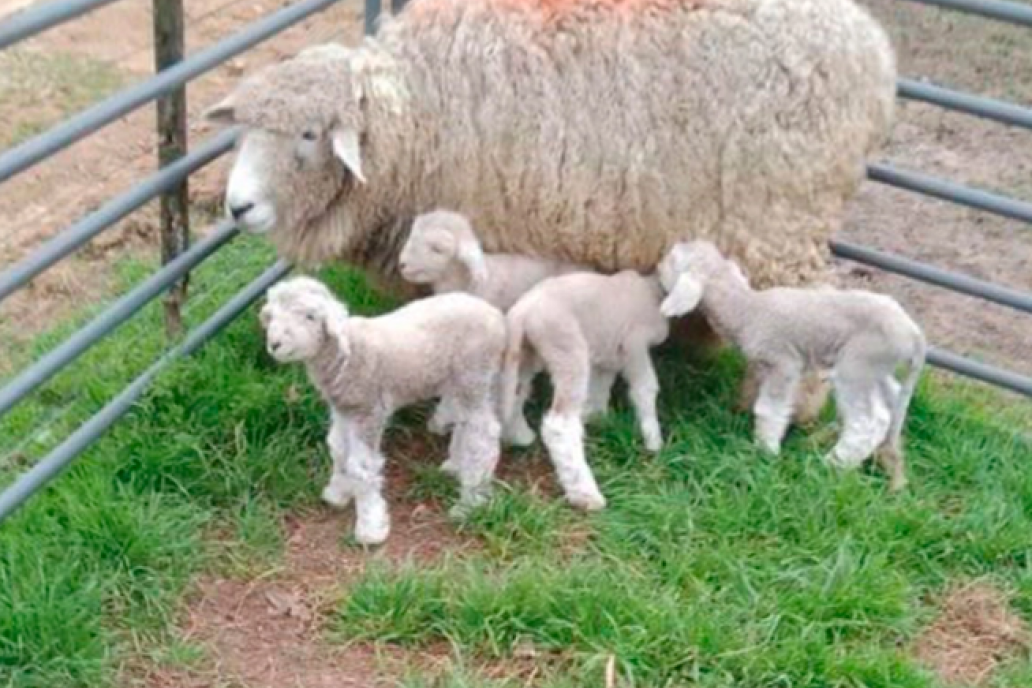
[{"xmin": 398, "ymin": 209, "xmax": 587, "ymax": 446}]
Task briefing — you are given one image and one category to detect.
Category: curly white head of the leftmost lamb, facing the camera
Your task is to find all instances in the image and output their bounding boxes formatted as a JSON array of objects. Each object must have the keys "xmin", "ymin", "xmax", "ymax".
[{"xmin": 258, "ymin": 276, "xmax": 350, "ymax": 363}]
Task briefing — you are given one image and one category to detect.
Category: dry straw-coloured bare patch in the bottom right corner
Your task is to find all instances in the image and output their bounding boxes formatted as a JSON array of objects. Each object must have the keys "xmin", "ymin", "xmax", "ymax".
[{"xmin": 914, "ymin": 582, "xmax": 1030, "ymax": 686}]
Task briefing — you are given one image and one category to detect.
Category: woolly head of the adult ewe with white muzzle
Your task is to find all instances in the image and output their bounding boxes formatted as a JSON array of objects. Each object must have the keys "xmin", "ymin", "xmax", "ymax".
[{"xmin": 205, "ymin": 44, "xmax": 366, "ymax": 242}]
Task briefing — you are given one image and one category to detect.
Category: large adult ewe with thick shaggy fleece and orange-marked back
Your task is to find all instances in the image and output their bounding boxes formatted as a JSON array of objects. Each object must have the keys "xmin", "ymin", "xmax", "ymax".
[{"xmin": 208, "ymin": 0, "xmax": 895, "ymax": 288}]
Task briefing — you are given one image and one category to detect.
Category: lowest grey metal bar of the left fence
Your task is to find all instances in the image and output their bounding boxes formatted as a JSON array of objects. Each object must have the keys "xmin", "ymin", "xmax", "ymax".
[{"xmin": 0, "ymin": 261, "xmax": 291, "ymax": 522}]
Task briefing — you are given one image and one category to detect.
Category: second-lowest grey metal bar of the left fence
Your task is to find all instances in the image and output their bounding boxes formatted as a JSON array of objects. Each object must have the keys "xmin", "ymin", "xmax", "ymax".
[{"xmin": 0, "ymin": 221, "xmax": 239, "ymax": 418}]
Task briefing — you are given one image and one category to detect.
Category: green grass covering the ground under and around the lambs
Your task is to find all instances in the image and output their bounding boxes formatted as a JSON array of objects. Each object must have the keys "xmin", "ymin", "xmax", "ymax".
[{"xmin": 0, "ymin": 240, "xmax": 1032, "ymax": 688}]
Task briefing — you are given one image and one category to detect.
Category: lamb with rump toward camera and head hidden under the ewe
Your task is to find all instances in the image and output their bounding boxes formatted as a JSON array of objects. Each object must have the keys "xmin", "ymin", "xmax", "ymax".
[{"xmin": 501, "ymin": 270, "xmax": 669, "ymax": 511}]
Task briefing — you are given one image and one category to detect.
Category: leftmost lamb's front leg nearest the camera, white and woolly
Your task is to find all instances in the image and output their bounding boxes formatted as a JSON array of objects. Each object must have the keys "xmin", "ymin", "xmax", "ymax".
[{"xmin": 345, "ymin": 416, "xmax": 390, "ymax": 545}]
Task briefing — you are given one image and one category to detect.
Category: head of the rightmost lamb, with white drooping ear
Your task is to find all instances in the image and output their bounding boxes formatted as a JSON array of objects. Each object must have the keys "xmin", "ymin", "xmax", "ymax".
[{"xmin": 656, "ymin": 239, "xmax": 748, "ymax": 318}]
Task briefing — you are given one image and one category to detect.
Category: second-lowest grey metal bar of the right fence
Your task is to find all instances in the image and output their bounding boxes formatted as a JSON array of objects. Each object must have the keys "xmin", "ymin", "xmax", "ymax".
[{"xmin": 829, "ymin": 239, "xmax": 1032, "ymax": 314}]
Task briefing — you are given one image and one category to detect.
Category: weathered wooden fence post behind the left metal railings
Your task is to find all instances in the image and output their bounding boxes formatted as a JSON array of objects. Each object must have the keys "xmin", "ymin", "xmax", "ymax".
[{"xmin": 153, "ymin": 0, "xmax": 190, "ymax": 337}]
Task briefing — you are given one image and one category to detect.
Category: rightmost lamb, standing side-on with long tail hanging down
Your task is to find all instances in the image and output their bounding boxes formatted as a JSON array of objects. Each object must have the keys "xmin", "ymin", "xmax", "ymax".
[{"xmin": 657, "ymin": 240, "xmax": 927, "ymax": 491}]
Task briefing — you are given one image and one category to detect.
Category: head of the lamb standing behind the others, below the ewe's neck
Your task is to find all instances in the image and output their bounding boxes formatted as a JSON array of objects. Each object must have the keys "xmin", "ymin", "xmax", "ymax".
[{"xmin": 398, "ymin": 209, "xmax": 487, "ymax": 286}]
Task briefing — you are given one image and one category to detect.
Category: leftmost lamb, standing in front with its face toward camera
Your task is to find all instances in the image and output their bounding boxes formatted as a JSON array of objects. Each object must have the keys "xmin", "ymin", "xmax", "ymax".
[{"xmin": 259, "ymin": 276, "xmax": 506, "ymax": 545}]
